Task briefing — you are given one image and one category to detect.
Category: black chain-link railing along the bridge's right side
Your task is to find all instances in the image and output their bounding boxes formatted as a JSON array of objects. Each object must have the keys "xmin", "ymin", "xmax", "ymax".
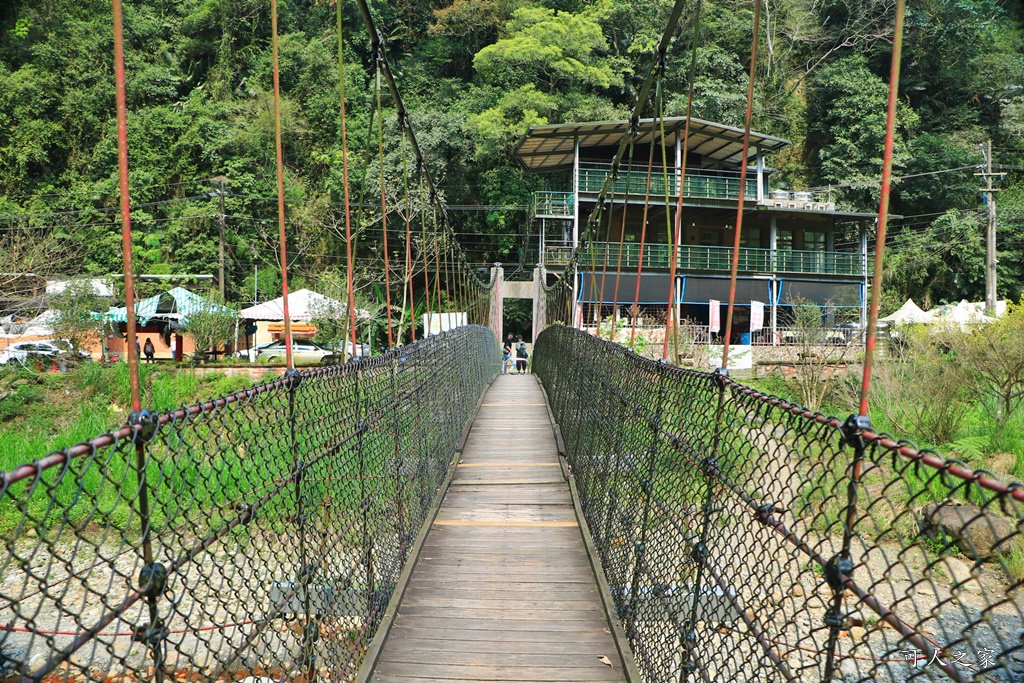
[{"xmin": 535, "ymin": 327, "xmax": 1024, "ymax": 683}]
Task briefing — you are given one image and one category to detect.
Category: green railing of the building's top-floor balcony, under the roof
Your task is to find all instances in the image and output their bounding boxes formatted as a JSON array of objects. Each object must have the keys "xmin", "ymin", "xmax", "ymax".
[{"xmin": 580, "ymin": 164, "xmax": 758, "ymax": 201}]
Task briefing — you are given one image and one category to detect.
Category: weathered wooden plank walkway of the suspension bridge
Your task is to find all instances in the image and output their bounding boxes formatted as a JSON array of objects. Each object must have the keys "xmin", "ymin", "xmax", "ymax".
[{"xmin": 369, "ymin": 375, "xmax": 626, "ymax": 683}]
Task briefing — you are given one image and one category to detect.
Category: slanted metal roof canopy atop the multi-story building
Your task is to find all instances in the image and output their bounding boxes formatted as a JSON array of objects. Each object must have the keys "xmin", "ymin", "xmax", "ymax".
[{"xmin": 515, "ymin": 117, "xmax": 791, "ymax": 171}]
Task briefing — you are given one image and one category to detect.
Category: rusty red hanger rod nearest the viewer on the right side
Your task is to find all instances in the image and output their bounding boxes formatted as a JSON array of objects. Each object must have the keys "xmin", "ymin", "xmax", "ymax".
[{"xmin": 860, "ymin": 0, "xmax": 905, "ymax": 416}]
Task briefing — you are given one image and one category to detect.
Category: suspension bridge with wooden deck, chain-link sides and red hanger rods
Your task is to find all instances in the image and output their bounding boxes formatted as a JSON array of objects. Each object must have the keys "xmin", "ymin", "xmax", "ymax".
[{"xmin": 0, "ymin": 0, "xmax": 1024, "ymax": 683}]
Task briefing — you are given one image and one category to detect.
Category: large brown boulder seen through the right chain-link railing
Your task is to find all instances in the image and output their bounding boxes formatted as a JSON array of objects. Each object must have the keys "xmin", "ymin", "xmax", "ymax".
[{"xmin": 920, "ymin": 501, "xmax": 1015, "ymax": 560}]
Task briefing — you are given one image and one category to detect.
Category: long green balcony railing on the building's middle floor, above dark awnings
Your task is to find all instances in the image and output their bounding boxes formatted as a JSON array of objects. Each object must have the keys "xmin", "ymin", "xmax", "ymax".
[{"xmin": 544, "ymin": 242, "xmax": 873, "ymax": 278}]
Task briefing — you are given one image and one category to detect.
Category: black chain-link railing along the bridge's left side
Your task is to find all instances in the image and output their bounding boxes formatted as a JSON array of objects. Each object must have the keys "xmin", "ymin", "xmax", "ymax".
[{"xmin": 0, "ymin": 326, "xmax": 499, "ymax": 682}]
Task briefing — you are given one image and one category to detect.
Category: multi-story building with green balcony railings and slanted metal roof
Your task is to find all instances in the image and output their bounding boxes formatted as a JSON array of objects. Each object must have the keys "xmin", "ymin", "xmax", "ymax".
[{"xmin": 516, "ymin": 118, "xmax": 874, "ymax": 343}]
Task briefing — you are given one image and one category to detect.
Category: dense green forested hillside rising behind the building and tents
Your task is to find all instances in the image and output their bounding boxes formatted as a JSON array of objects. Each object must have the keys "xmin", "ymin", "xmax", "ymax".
[{"xmin": 0, "ymin": 0, "xmax": 1024, "ymax": 306}]
